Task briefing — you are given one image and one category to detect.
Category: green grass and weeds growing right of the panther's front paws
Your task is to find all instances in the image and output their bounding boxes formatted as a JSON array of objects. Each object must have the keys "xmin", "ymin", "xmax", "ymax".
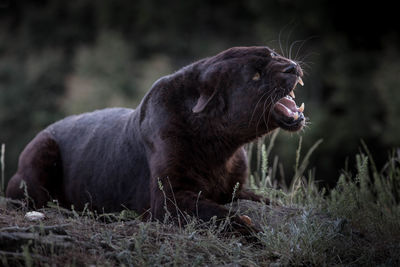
[{"xmin": 250, "ymin": 134, "xmax": 400, "ymax": 266}]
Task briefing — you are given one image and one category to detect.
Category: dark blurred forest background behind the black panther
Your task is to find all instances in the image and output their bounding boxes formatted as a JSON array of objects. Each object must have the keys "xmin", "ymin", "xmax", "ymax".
[{"xmin": 0, "ymin": 0, "xmax": 400, "ymax": 188}]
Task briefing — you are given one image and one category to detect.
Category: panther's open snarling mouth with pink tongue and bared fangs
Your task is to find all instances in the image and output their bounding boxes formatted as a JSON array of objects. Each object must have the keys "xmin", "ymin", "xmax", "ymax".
[{"xmin": 272, "ymin": 76, "xmax": 305, "ymax": 131}]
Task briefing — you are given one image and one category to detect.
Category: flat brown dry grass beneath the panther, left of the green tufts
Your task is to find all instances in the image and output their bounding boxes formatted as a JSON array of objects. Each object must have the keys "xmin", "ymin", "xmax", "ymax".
[{"xmin": 0, "ymin": 199, "xmax": 276, "ymax": 266}]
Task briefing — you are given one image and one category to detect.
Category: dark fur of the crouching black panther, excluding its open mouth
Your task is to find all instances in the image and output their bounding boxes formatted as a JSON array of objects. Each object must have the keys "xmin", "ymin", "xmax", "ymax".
[{"xmin": 7, "ymin": 47, "xmax": 304, "ymax": 233}]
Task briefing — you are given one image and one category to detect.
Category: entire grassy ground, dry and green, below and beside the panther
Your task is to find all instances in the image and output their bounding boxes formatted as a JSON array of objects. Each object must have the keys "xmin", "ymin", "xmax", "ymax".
[{"xmin": 0, "ymin": 135, "xmax": 400, "ymax": 266}]
